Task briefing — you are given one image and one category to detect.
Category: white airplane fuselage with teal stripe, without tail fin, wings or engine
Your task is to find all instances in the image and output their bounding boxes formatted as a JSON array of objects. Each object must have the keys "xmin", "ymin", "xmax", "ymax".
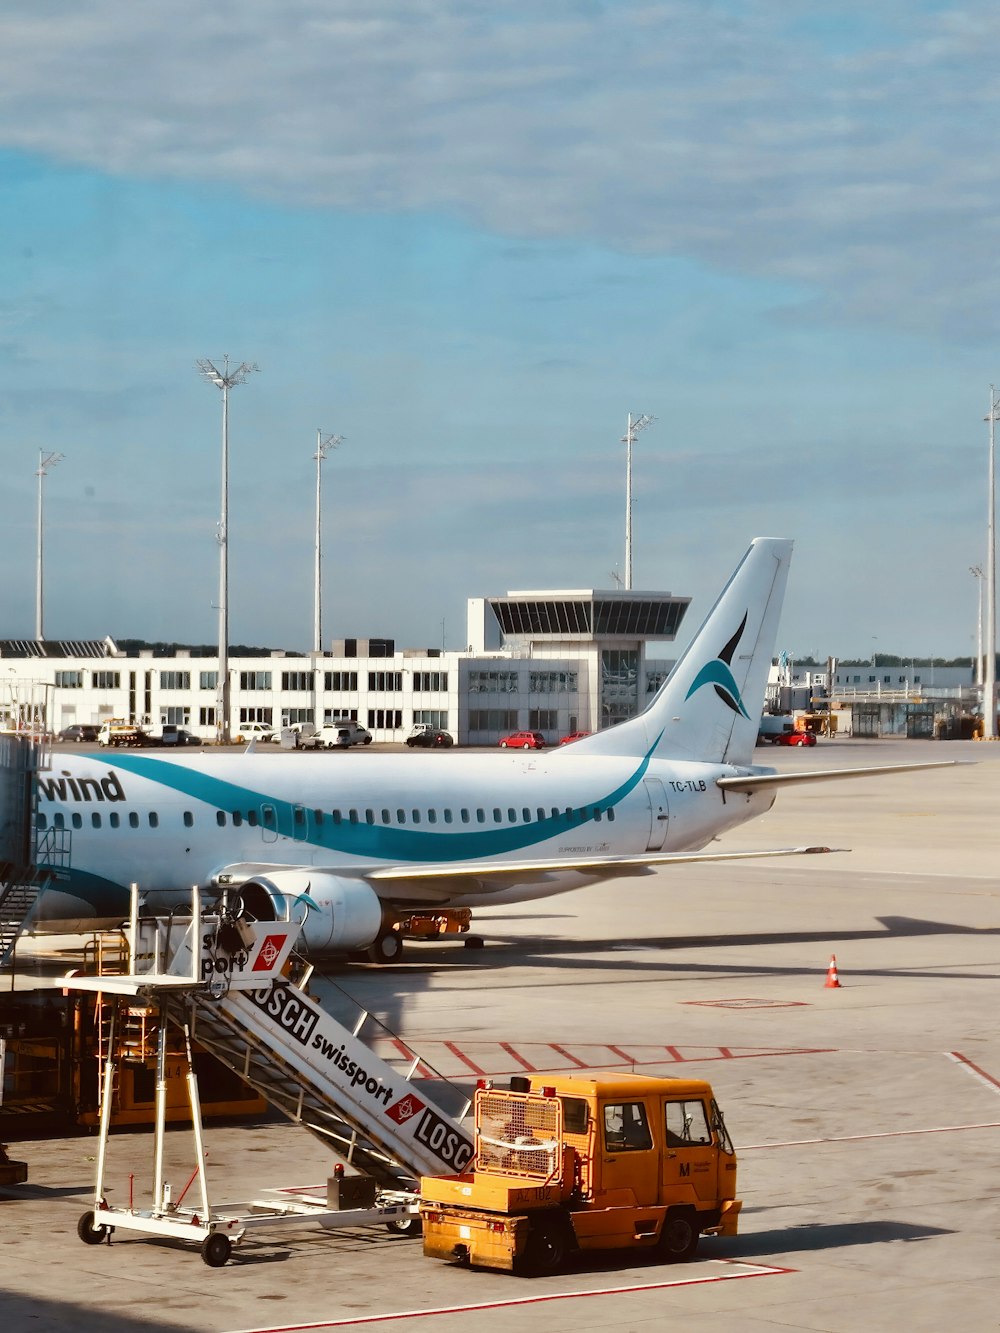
[{"xmin": 37, "ymin": 750, "xmax": 772, "ymax": 925}]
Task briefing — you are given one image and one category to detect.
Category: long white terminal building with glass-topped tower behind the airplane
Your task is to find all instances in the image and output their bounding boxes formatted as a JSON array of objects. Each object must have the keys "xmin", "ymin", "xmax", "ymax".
[{"xmin": 0, "ymin": 589, "xmax": 691, "ymax": 745}]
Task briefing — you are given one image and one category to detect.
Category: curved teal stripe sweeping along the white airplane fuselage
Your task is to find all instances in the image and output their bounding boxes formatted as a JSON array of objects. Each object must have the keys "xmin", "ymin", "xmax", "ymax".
[{"xmin": 98, "ymin": 737, "xmax": 659, "ymax": 862}]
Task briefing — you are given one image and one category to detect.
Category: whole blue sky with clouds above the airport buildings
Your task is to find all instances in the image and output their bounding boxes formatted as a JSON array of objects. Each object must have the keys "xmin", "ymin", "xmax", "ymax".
[{"xmin": 0, "ymin": 0, "xmax": 1000, "ymax": 656}]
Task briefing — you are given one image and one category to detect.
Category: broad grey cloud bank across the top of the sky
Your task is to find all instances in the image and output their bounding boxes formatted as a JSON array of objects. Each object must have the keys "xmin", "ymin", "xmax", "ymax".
[{"xmin": 0, "ymin": 0, "xmax": 1000, "ymax": 337}]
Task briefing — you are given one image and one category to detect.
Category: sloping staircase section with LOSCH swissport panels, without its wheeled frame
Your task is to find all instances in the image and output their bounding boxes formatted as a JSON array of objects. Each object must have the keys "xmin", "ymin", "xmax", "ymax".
[{"xmin": 68, "ymin": 914, "xmax": 472, "ymax": 1192}]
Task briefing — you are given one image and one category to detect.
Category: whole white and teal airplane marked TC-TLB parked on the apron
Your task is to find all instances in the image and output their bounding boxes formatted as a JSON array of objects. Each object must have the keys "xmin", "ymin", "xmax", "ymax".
[{"xmin": 33, "ymin": 539, "xmax": 954, "ymax": 962}]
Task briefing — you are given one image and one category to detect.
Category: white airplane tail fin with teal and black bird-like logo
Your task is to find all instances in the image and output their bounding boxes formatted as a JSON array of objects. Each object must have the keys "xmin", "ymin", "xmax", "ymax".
[{"xmin": 572, "ymin": 537, "xmax": 792, "ymax": 764}]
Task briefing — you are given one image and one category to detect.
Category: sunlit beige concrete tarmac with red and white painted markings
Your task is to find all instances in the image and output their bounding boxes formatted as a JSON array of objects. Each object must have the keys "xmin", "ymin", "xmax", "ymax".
[{"xmin": 0, "ymin": 740, "xmax": 1000, "ymax": 1333}]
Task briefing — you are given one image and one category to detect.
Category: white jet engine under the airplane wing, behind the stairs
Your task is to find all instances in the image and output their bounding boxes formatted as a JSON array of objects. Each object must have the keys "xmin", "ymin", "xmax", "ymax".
[{"xmin": 229, "ymin": 870, "xmax": 384, "ymax": 953}]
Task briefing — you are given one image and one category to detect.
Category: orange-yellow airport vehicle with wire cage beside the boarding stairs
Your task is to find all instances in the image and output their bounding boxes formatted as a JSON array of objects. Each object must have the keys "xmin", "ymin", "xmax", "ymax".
[{"xmin": 420, "ymin": 1074, "xmax": 740, "ymax": 1276}]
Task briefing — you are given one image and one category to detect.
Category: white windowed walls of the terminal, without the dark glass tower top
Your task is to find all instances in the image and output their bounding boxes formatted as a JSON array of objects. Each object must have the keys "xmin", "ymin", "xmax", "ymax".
[{"xmin": 0, "ymin": 599, "xmax": 688, "ymax": 745}]
